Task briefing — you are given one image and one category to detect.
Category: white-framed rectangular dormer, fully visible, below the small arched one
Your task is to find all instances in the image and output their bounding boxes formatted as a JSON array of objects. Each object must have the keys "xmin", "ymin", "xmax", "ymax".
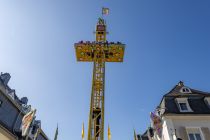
[{"xmin": 176, "ymin": 98, "xmax": 192, "ymax": 112}]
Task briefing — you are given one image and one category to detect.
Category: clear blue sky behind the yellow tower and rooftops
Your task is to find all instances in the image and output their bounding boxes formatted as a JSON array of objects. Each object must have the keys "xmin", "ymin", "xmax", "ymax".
[{"xmin": 0, "ymin": 0, "xmax": 210, "ymax": 140}]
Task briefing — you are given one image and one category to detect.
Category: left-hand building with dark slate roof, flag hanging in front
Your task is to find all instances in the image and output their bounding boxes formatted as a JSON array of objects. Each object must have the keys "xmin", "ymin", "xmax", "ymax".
[{"xmin": 0, "ymin": 73, "xmax": 48, "ymax": 140}]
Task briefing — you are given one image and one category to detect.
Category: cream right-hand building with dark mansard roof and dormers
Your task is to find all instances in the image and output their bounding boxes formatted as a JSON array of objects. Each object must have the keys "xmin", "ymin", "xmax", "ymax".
[{"xmin": 139, "ymin": 82, "xmax": 210, "ymax": 140}]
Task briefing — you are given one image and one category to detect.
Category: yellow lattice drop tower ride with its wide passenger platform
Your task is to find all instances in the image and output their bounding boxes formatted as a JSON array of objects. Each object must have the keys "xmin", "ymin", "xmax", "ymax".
[{"xmin": 74, "ymin": 18, "xmax": 125, "ymax": 140}]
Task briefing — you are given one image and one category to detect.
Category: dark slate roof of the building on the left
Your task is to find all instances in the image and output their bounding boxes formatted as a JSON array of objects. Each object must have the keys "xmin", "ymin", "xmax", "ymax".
[{"xmin": 0, "ymin": 73, "xmax": 49, "ymax": 140}]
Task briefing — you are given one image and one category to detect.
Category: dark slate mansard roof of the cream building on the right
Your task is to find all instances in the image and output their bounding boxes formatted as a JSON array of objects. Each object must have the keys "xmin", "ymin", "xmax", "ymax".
[{"xmin": 160, "ymin": 82, "xmax": 210, "ymax": 114}]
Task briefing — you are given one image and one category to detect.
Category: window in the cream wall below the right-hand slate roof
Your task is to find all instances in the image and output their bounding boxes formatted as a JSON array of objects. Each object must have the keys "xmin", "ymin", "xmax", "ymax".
[{"xmin": 187, "ymin": 128, "xmax": 203, "ymax": 140}]
